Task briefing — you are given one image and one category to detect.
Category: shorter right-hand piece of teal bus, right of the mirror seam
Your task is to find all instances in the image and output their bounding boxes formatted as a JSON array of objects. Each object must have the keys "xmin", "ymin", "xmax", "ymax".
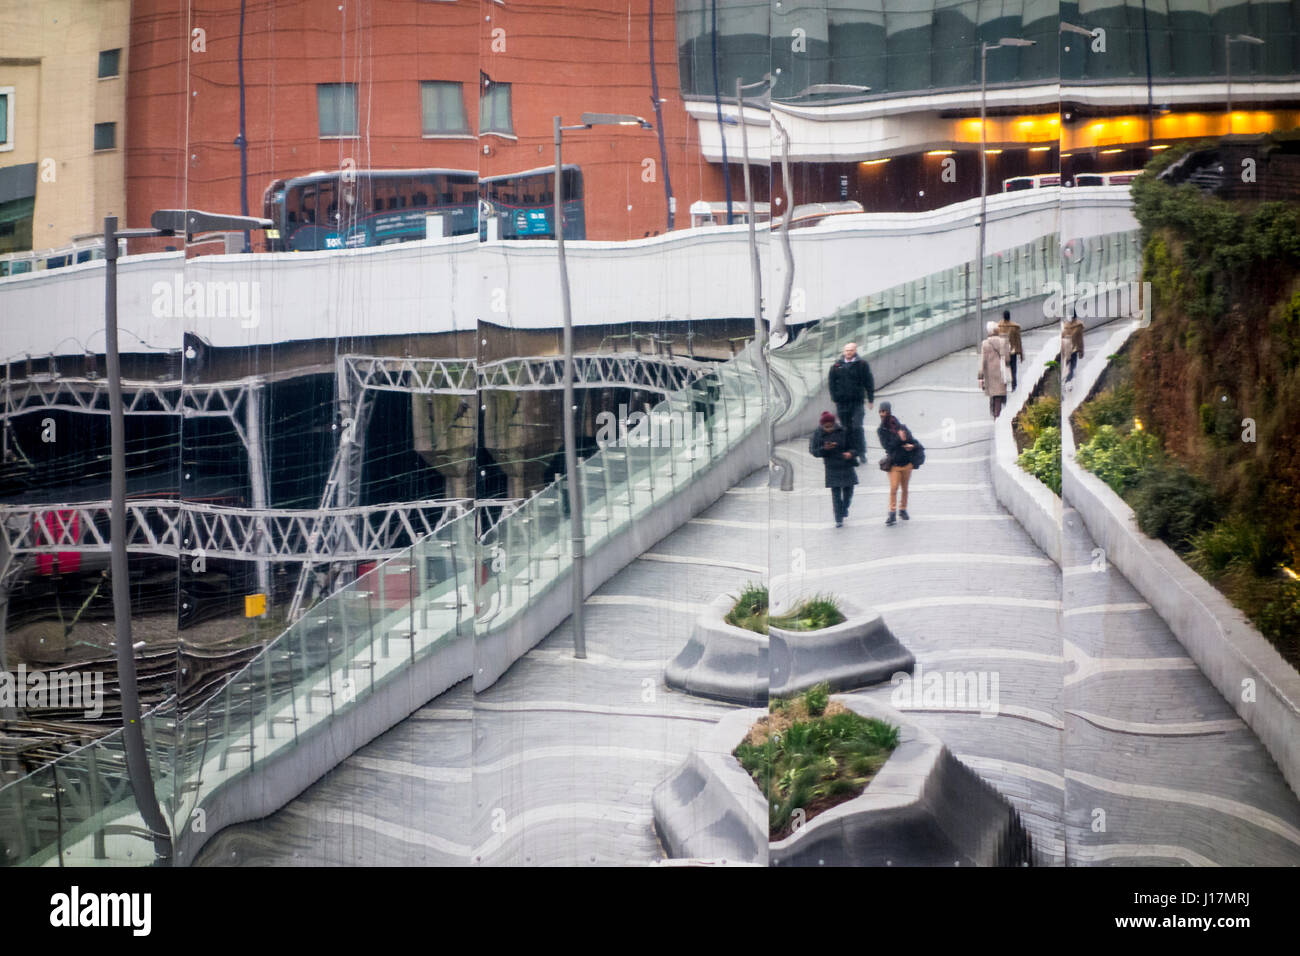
[{"xmin": 478, "ymin": 163, "xmax": 586, "ymax": 239}]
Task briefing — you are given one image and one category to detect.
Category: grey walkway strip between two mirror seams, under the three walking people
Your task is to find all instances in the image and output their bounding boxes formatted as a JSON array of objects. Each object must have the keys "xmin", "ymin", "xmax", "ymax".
[{"xmin": 772, "ymin": 329, "xmax": 1066, "ymax": 864}]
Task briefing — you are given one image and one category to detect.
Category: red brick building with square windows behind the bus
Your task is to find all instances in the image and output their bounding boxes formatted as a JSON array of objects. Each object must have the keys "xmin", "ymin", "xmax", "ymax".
[{"xmin": 126, "ymin": 0, "xmax": 740, "ymax": 247}]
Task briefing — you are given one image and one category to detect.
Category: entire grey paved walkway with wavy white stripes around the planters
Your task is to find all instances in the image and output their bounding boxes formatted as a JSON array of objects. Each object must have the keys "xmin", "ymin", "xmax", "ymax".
[{"xmin": 199, "ymin": 329, "xmax": 1300, "ymax": 865}]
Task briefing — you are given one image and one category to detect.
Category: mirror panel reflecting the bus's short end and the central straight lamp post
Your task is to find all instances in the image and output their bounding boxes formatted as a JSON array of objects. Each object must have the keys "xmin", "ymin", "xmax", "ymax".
[{"xmin": 469, "ymin": 3, "xmax": 771, "ymax": 865}]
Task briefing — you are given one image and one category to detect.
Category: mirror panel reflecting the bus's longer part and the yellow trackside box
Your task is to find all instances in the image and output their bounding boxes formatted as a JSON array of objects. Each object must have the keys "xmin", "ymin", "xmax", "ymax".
[{"xmin": 174, "ymin": 0, "xmax": 478, "ymax": 865}]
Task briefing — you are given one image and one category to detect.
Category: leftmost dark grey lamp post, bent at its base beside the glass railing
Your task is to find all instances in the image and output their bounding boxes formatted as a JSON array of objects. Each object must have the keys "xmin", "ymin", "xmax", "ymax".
[{"xmin": 104, "ymin": 209, "xmax": 272, "ymax": 864}]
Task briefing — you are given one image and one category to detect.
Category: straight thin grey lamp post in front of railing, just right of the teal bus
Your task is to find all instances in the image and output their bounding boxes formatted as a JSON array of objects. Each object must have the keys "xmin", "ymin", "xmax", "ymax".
[{"xmin": 554, "ymin": 113, "xmax": 654, "ymax": 659}]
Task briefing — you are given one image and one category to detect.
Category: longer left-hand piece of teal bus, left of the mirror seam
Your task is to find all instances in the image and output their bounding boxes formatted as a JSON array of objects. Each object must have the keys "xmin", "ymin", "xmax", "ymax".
[{"xmin": 263, "ymin": 169, "xmax": 478, "ymax": 252}]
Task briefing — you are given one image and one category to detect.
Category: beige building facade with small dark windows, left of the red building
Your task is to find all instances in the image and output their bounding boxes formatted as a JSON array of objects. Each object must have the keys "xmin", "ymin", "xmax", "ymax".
[{"xmin": 0, "ymin": 0, "xmax": 131, "ymax": 254}]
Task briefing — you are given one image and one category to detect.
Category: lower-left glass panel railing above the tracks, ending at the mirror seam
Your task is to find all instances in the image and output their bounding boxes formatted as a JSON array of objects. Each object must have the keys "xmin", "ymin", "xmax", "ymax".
[{"xmin": 0, "ymin": 515, "xmax": 478, "ymax": 866}]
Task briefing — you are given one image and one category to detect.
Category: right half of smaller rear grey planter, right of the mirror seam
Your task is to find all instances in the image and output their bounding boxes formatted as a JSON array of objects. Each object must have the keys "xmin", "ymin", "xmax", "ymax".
[{"xmin": 768, "ymin": 597, "xmax": 917, "ymax": 697}]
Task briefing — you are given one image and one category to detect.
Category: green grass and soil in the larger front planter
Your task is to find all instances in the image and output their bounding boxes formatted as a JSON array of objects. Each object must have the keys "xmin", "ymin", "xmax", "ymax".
[{"xmin": 735, "ymin": 684, "xmax": 898, "ymax": 840}]
